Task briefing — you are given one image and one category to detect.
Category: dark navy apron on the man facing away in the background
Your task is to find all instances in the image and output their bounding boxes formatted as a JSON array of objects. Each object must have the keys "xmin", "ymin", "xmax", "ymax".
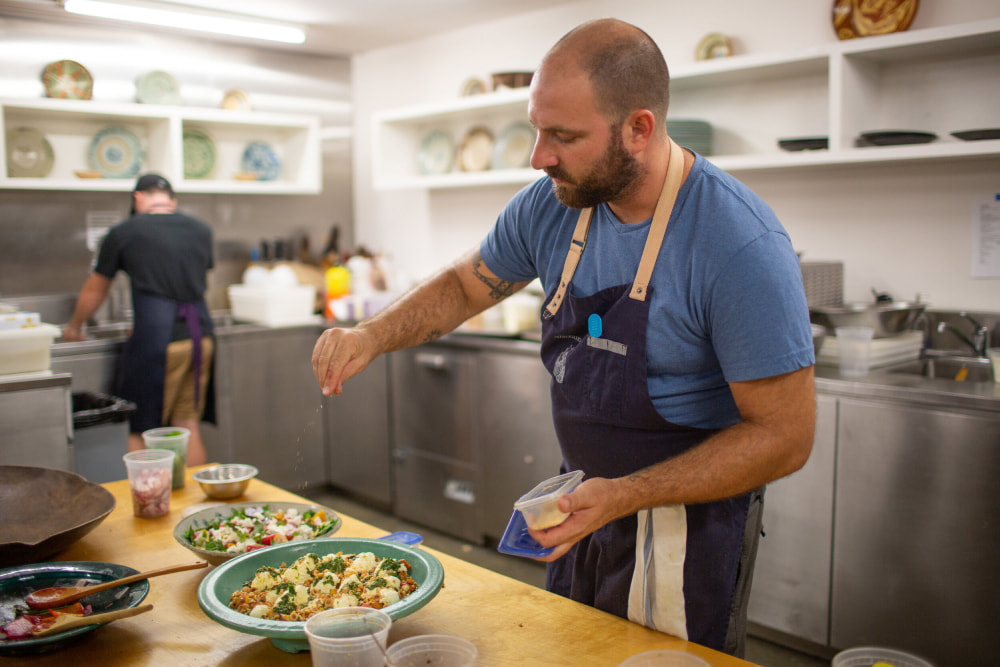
[{"xmin": 116, "ymin": 290, "xmax": 215, "ymax": 433}]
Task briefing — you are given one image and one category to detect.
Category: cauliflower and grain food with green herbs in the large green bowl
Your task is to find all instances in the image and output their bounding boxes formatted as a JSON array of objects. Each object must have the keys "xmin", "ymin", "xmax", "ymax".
[{"xmin": 229, "ymin": 552, "xmax": 417, "ymax": 621}]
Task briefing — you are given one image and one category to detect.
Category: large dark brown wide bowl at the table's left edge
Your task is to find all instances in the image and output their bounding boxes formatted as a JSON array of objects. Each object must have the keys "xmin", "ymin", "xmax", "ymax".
[{"xmin": 0, "ymin": 466, "xmax": 115, "ymax": 567}]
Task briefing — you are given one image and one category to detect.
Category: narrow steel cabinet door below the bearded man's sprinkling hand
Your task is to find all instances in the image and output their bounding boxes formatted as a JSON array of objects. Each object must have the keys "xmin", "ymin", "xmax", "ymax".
[{"xmin": 323, "ymin": 354, "xmax": 392, "ymax": 507}]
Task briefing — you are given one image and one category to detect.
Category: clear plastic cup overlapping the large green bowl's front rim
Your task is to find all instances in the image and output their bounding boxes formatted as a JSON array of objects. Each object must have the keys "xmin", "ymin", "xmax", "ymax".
[{"xmin": 305, "ymin": 607, "xmax": 392, "ymax": 667}]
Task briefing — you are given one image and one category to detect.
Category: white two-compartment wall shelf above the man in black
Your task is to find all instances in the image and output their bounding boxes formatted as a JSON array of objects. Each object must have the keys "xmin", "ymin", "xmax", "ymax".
[{"xmin": 0, "ymin": 99, "xmax": 322, "ymax": 194}]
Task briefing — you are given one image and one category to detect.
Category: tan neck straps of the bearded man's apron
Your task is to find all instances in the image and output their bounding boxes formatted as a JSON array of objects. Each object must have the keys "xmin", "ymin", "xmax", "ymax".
[{"xmin": 542, "ymin": 139, "xmax": 684, "ymax": 319}]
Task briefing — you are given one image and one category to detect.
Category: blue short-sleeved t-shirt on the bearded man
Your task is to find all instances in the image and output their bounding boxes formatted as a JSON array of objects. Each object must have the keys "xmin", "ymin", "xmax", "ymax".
[{"xmin": 481, "ymin": 155, "xmax": 815, "ymax": 429}]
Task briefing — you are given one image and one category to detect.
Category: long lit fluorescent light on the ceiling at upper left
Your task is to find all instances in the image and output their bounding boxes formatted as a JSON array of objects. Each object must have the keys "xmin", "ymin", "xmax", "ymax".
[{"xmin": 63, "ymin": 0, "xmax": 306, "ymax": 44}]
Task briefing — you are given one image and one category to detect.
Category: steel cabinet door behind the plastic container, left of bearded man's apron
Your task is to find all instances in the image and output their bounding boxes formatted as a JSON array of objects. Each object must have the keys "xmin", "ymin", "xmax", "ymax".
[{"xmin": 477, "ymin": 352, "xmax": 562, "ymax": 541}]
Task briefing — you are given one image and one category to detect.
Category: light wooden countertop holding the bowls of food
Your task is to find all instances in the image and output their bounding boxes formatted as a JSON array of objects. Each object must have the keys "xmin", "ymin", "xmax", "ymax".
[{"xmin": 2, "ymin": 468, "xmax": 751, "ymax": 667}]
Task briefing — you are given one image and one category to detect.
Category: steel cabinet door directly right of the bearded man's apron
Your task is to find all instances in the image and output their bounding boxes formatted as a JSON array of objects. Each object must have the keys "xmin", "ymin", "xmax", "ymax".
[{"xmin": 749, "ymin": 396, "xmax": 837, "ymax": 645}]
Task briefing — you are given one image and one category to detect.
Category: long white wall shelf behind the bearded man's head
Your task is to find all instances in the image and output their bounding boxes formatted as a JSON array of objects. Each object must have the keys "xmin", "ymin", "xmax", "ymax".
[{"xmin": 372, "ymin": 19, "xmax": 1000, "ymax": 190}]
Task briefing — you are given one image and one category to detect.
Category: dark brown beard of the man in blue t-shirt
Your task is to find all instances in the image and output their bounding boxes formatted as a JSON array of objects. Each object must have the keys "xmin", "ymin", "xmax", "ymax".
[{"xmin": 545, "ymin": 133, "xmax": 642, "ymax": 209}]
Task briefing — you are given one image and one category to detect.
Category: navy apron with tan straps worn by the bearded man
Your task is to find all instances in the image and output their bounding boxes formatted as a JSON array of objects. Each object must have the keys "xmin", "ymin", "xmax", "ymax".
[{"xmin": 541, "ymin": 142, "xmax": 750, "ymax": 650}]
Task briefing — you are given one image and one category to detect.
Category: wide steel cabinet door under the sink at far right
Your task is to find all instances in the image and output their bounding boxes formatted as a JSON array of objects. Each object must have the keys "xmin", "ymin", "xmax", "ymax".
[{"xmin": 830, "ymin": 398, "xmax": 1000, "ymax": 665}]
